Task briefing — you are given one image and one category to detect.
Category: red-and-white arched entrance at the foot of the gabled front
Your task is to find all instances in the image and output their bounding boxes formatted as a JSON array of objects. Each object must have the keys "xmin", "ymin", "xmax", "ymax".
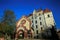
[{"xmin": 16, "ymin": 27, "xmax": 27, "ymax": 38}]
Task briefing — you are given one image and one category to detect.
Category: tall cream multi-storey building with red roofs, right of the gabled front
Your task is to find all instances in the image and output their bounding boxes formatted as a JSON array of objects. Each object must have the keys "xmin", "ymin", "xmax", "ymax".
[{"xmin": 28, "ymin": 9, "xmax": 55, "ymax": 35}]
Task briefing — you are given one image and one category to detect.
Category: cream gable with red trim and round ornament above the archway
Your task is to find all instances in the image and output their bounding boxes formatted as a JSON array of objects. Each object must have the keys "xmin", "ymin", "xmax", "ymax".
[{"xmin": 16, "ymin": 16, "xmax": 31, "ymax": 30}]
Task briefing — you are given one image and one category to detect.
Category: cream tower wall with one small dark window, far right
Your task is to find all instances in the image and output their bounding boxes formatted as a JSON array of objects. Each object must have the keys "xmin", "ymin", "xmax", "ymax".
[{"xmin": 44, "ymin": 12, "xmax": 55, "ymax": 27}]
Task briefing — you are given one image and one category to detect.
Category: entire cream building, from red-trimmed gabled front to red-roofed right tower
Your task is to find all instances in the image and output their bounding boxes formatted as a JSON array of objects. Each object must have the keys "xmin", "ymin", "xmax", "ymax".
[{"xmin": 16, "ymin": 9, "xmax": 55, "ymax": 37}]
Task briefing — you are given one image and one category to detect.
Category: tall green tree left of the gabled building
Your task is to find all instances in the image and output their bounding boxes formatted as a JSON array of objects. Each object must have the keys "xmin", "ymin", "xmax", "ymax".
[{"xmin": 2, "ymin": 10, "xmax": 16, "ymax": 35}]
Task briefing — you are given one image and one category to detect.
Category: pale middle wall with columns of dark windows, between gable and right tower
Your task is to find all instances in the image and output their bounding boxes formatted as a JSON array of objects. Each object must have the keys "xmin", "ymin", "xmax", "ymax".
[{"xmin": 29, "ymin": 10, "xmax": 45, "ymax": 35}]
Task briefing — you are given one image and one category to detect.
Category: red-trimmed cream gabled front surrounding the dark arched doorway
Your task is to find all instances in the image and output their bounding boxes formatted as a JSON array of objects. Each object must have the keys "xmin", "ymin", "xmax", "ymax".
[{"xmin": 16, "ymin": 16, "xmax": 32, "ymax": 38}]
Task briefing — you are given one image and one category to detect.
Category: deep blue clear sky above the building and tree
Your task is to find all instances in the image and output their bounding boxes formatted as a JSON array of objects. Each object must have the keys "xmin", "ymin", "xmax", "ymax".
[{"xmin": 0, "ymin": 0, "xmax": 60, "ymax": 29}]
